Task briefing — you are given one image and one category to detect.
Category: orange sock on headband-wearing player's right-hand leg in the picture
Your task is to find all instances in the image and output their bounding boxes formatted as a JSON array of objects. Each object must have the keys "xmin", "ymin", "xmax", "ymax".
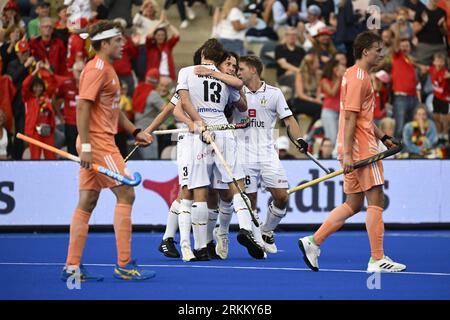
[{"xmin": 114, "ymin": 203, "xmax": 132, "ymax": 267}]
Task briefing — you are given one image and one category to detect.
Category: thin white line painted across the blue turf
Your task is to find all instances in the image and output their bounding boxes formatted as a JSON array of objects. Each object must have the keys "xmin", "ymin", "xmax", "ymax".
[{"xmin": 0, "ymin": 262, "xmax": 450, "ymax": 277}]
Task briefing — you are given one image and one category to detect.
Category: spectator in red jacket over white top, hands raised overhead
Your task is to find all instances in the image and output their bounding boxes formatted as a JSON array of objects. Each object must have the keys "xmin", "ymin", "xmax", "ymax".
[{"xmin": 146, "ymin": 17, "xmax": 180, "ymax": 81}]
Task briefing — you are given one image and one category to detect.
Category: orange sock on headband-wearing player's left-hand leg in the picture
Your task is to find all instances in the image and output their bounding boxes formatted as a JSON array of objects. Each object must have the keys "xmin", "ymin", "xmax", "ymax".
[{"xmin": 66, "ymin": 208, "xmax": 91, "ymax": 266}]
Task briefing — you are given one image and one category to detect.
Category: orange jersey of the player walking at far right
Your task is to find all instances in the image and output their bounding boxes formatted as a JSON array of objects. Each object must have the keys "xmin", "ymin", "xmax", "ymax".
[{"xmin": 337, "ymin": 64, "xmax": 378, "ymax": 161}]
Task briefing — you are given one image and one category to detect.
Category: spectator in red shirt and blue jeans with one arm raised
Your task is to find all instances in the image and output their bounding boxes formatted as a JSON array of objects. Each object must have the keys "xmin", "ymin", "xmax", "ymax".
[{"xmin": 391, "ymin": 27, "xmax": 420, "ymax": 139}]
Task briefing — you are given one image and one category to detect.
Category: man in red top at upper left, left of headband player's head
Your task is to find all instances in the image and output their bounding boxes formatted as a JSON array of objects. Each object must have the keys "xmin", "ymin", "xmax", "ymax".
[{"xmin": 30, "ymin": 18, "xmax": 67, "ymax": 75}]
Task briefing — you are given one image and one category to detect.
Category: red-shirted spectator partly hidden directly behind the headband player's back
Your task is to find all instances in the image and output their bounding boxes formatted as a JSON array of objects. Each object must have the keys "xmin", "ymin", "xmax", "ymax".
[{"xmin": 56, "ymin": 61, "xmax": 84, "ymax": 155}]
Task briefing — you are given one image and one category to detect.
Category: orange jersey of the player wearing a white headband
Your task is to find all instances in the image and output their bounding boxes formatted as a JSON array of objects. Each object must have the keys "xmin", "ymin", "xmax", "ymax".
[{"xmin": 79, "ymin": 56, "xmax": 120, "ymax": 135}]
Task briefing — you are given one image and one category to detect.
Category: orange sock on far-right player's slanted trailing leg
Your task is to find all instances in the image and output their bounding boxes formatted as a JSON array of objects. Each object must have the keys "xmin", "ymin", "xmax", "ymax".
[{"xmin": 314, "ymin": 202, "xmax": 354, "ymax": 246}]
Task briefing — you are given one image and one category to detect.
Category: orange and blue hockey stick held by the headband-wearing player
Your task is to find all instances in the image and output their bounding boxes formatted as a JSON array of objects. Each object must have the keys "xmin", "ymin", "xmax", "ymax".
[{"xmin": 16, "ymin": 133, "xmax": 142, "ymax": 187}]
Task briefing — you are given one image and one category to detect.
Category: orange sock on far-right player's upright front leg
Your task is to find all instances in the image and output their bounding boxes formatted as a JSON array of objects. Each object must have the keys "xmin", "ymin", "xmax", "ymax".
[{"xmin": 366, "ymin": 206, "xmax": 384, "ymax": 260}]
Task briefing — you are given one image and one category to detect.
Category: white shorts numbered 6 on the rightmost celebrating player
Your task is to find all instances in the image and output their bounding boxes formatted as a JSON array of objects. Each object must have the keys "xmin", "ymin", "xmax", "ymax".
[{"xmin": 244, "ymin": 153, "xmax": 288, "ymax": 193}]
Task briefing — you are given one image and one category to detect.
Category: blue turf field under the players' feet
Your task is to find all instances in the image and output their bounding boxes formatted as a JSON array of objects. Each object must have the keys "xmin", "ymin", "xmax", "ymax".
[{"xmin": 0, "ymin": 231, "xmax": 450, "ymax": 300}]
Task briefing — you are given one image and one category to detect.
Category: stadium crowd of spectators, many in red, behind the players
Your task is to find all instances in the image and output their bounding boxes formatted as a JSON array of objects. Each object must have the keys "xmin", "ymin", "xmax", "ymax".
[{"xmin": 0, "ymin": 0, "xmax": 450, "ymax": 160}]
